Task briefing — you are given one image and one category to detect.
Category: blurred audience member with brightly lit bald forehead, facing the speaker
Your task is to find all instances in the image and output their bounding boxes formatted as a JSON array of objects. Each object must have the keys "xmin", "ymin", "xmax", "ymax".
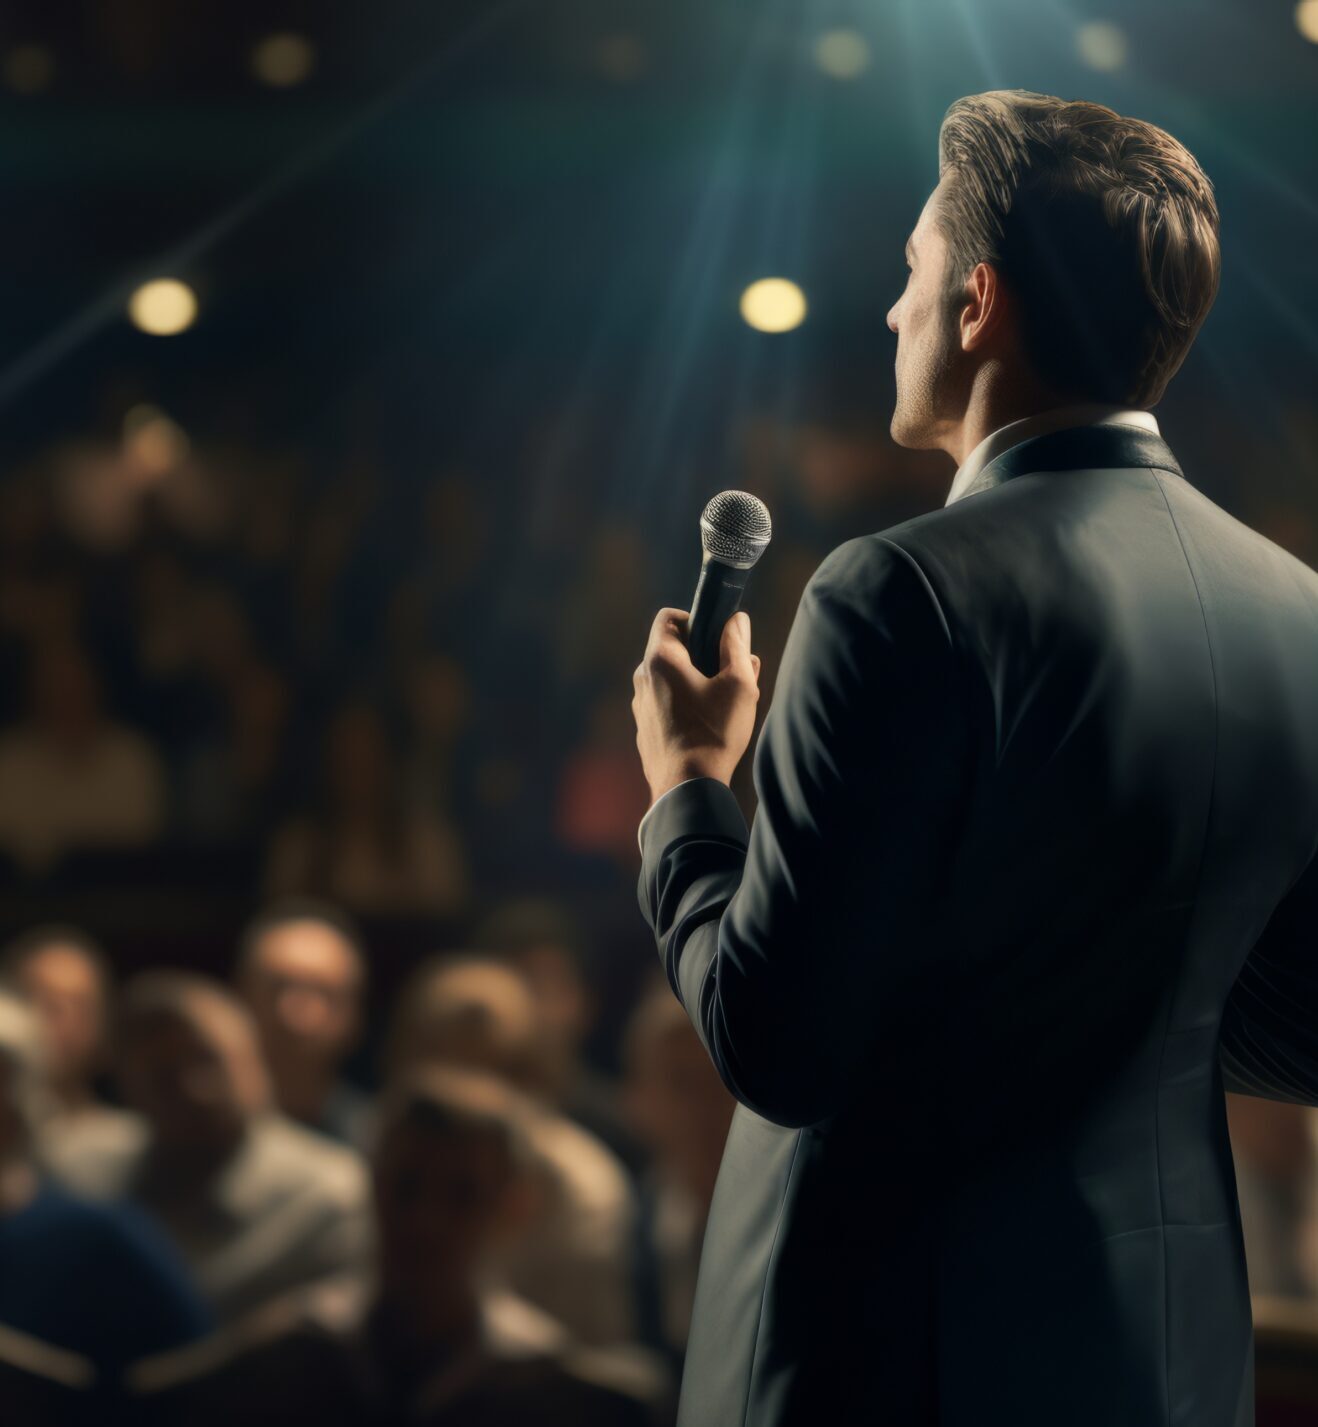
[{"xmin": 235, "ymin": 900, "xmax": 371, "ymax": 1149}]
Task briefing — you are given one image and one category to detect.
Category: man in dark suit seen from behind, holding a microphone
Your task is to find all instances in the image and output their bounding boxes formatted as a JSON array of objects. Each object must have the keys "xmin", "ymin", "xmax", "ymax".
[{"xmin": 633, "ymin": 91, "xmax": 1318, "ymax": 1427}]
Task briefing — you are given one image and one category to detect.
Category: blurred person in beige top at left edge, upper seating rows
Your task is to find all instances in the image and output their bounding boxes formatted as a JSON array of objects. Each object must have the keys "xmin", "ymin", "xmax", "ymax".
[{"xmin": 0, "ymin": 645, "xmax": 165, "ymax": 872}]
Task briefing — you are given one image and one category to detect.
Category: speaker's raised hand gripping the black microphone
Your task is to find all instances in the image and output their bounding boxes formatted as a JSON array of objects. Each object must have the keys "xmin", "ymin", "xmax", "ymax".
[{"xmin": 632, "ymin": 609, "xmax": 760, "ymax": 802}]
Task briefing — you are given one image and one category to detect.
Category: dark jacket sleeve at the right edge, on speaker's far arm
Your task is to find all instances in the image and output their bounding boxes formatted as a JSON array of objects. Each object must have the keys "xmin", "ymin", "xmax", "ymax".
[{"xmin": 1220, "ymin": 858, "xmax": 1318, "ymax": 1104}]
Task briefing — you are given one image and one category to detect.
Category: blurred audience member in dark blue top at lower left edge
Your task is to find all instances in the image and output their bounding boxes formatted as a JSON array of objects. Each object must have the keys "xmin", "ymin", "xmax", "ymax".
[{"xmin": 0, "ymin": 992, "xmax": 210, "ymax": 1381}]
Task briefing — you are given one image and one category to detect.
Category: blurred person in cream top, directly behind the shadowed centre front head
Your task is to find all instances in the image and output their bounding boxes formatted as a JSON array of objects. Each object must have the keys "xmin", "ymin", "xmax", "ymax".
[{"xmin": 387, "ymin": 956, "xmax": 635, "ymax": 1344}]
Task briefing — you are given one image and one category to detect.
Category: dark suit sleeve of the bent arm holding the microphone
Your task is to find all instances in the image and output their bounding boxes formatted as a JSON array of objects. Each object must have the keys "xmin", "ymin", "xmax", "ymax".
[{"xmin": 639, "ymin": 537, "xmax": 969, "ymax": 1126}]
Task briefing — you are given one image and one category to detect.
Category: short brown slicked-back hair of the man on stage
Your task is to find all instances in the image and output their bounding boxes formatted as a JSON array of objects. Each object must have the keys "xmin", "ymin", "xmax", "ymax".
[{"xmin": 937, "ymin": 90, "xmax": 1221, "ymax": 407}]
